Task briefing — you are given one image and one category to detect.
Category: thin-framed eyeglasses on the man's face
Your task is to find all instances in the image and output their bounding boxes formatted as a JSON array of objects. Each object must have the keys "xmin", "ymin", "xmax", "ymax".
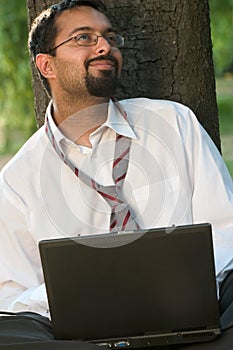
[{"xmin": 51, "ymin": 33, "xmax": 124, "ymax": 51}]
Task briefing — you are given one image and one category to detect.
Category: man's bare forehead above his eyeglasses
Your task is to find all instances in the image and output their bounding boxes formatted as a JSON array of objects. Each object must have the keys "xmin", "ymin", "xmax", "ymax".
[{"xmin": 56, "ymin": 6, "xmax": 112, "ymax": 37}]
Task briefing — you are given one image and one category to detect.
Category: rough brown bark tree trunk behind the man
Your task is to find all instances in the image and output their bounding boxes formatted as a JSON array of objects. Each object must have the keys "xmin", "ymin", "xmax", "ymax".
[{"xmin": 27, "ymin": 0, "xmax": 220, "ymax": 149}]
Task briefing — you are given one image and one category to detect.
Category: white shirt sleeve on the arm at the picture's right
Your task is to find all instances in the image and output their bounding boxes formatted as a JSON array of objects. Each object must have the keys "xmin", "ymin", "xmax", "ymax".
[{"xmin": 186, "ymin": 111, "xmax": 233, "ymax": 283}]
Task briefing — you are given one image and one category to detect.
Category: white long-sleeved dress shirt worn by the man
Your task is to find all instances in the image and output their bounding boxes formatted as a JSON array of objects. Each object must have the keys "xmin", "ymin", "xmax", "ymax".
[{"xmin": 0, "ymin": 98, "xmax": 233, "ymax": 314}]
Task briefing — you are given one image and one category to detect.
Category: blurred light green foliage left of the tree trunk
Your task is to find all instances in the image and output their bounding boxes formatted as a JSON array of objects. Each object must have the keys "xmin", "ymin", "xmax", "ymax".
[{"xmin": 0, "ymin": 0, "xmax": 36, "ymax": 151}]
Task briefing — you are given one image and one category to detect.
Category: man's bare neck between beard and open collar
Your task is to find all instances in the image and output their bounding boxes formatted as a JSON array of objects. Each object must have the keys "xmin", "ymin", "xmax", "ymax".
[{"xmin": 52, "ymin": 97, "xmax": 109, "ymax": 147}]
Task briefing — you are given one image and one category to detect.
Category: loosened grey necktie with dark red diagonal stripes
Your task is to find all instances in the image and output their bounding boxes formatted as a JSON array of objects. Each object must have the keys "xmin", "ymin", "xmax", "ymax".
[{"xmin": 45, "ymin": 102, "xmax": 139, "ymax": 232}]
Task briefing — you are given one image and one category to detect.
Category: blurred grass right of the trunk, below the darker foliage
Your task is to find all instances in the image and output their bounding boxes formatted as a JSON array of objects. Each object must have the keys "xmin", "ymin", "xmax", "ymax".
[{"xmin": 216, "ymin": 78, "xmax": 233, "ymax": 177}]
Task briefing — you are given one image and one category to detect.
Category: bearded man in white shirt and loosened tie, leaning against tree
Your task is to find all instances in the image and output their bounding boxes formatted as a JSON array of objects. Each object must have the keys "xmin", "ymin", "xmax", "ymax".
[{"xmin": 0, "ymin": 0, "xmax": 233, "ymax": 349}]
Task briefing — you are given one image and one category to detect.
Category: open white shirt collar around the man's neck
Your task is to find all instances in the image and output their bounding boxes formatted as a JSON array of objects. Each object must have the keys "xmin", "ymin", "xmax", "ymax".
[{"xmin": 46, "ymin": 100, "xmax": 137, "ymax": 152}]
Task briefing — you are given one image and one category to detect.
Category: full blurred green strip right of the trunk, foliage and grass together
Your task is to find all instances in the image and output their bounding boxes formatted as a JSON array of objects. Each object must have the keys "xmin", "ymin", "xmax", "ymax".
[{"xmin": 209, "ymin": 0, "xmax": 233, "ymax": 176}]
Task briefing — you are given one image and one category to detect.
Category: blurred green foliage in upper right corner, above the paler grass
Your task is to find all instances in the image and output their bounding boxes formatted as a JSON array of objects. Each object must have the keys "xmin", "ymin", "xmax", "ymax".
[{"xmin": 209, "ymin": 0, "xmax": 233, "ymax": 76}]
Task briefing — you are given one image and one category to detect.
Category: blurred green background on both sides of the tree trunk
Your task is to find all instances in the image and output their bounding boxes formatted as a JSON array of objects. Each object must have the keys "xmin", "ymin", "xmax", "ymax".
[{"xmin": 0, "ymin": 0, "xmax": 233, "ymax": 175}]
